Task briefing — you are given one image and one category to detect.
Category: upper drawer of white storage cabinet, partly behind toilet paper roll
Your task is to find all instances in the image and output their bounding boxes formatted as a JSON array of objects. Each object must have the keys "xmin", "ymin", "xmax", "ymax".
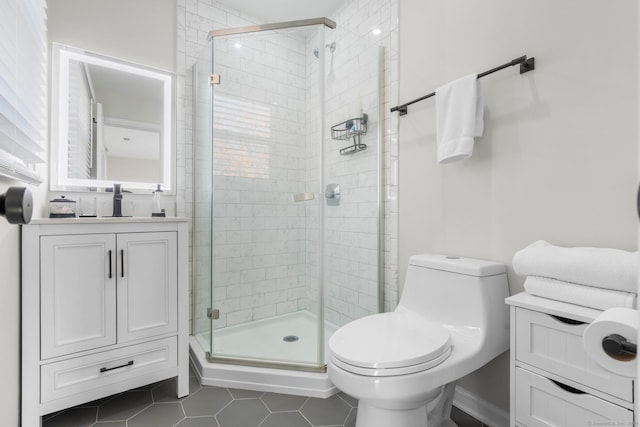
[{"xmin": 515, "ymin": 308, "xmax": 633, "ymax": 402}]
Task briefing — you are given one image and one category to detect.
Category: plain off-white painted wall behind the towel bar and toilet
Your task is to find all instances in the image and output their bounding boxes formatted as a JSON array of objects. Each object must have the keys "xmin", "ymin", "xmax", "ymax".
[{"xmin": 399, "ymin": 0, "xmax": 638, "ymax": 420}]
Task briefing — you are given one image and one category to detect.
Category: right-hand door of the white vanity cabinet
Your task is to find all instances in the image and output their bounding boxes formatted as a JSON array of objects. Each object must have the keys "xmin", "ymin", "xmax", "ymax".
[{"xmin": 117, "ymin": 232, "xmax": 178, "ymax": 342}]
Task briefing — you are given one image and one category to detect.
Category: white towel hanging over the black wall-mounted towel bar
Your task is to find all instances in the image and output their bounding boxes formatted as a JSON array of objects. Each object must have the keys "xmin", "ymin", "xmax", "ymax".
[{"xmin": 436, "ymin": 74, "xmax": 484, "ymax": 163}]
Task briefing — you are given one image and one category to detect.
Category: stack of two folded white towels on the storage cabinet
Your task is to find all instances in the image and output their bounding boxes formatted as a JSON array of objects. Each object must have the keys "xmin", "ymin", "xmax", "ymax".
[{"xmin": 513, "ymin": 240, "xmax": 638, "ymax": 310}]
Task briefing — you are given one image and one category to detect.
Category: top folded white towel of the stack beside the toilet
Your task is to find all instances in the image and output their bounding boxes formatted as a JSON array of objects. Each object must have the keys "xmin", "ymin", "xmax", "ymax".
[{"xmin": 513, "ymin": 240, "xmax": 638, "ymax": 293}]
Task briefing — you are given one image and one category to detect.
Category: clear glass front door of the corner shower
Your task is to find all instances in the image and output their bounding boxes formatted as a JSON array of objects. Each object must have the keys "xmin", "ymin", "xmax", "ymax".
[{"xmin": 209, "ymin": 26, "xmax": 324, "ymax": 369}]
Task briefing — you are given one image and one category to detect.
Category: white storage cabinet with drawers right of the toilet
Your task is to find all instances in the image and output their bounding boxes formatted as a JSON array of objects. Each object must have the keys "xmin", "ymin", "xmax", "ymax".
[{"xmin": 506, "ymin": 293, "xmax": 634, "ymax": 427}]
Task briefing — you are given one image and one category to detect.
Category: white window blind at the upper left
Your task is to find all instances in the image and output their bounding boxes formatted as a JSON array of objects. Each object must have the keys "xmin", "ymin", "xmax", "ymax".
[{"xmin": 0, "ymin": 0, "xmax": 47, "ymax": 184}]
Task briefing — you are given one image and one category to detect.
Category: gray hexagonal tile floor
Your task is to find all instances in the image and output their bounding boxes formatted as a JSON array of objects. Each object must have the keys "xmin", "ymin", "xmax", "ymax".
[{"xmin": 43, "ymin": 366, "xmax": 482, "ymax": 427}]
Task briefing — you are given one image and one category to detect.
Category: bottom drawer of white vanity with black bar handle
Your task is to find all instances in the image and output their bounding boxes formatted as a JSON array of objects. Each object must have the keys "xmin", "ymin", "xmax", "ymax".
[{"xmin": 40, "ymin": 337, "xmax": 178, "ymax": 403}]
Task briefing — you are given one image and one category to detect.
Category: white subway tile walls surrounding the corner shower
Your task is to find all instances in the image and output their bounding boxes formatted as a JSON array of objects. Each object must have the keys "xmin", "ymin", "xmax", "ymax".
[{"xmin": 177, "ymin": 0, "xmax": 398, "ymax": 342}]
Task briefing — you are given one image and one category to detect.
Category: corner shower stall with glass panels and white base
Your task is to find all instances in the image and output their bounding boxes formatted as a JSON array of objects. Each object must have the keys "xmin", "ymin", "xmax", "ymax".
[{"xmin": 191, "ymin": 18, "xmax": 384, "ymax": 397}]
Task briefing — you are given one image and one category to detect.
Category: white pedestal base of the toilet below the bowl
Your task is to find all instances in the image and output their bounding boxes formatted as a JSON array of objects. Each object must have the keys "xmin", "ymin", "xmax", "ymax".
[{"xmin": 356, "ymin": 382, "xmax": 457, "ymax": 427}]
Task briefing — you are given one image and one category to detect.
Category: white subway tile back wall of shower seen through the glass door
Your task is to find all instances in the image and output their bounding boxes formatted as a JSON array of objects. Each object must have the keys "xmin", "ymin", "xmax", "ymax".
[{"xmin": 213, "ymin": 32, "xmax": 307, "ymax": 328}]
